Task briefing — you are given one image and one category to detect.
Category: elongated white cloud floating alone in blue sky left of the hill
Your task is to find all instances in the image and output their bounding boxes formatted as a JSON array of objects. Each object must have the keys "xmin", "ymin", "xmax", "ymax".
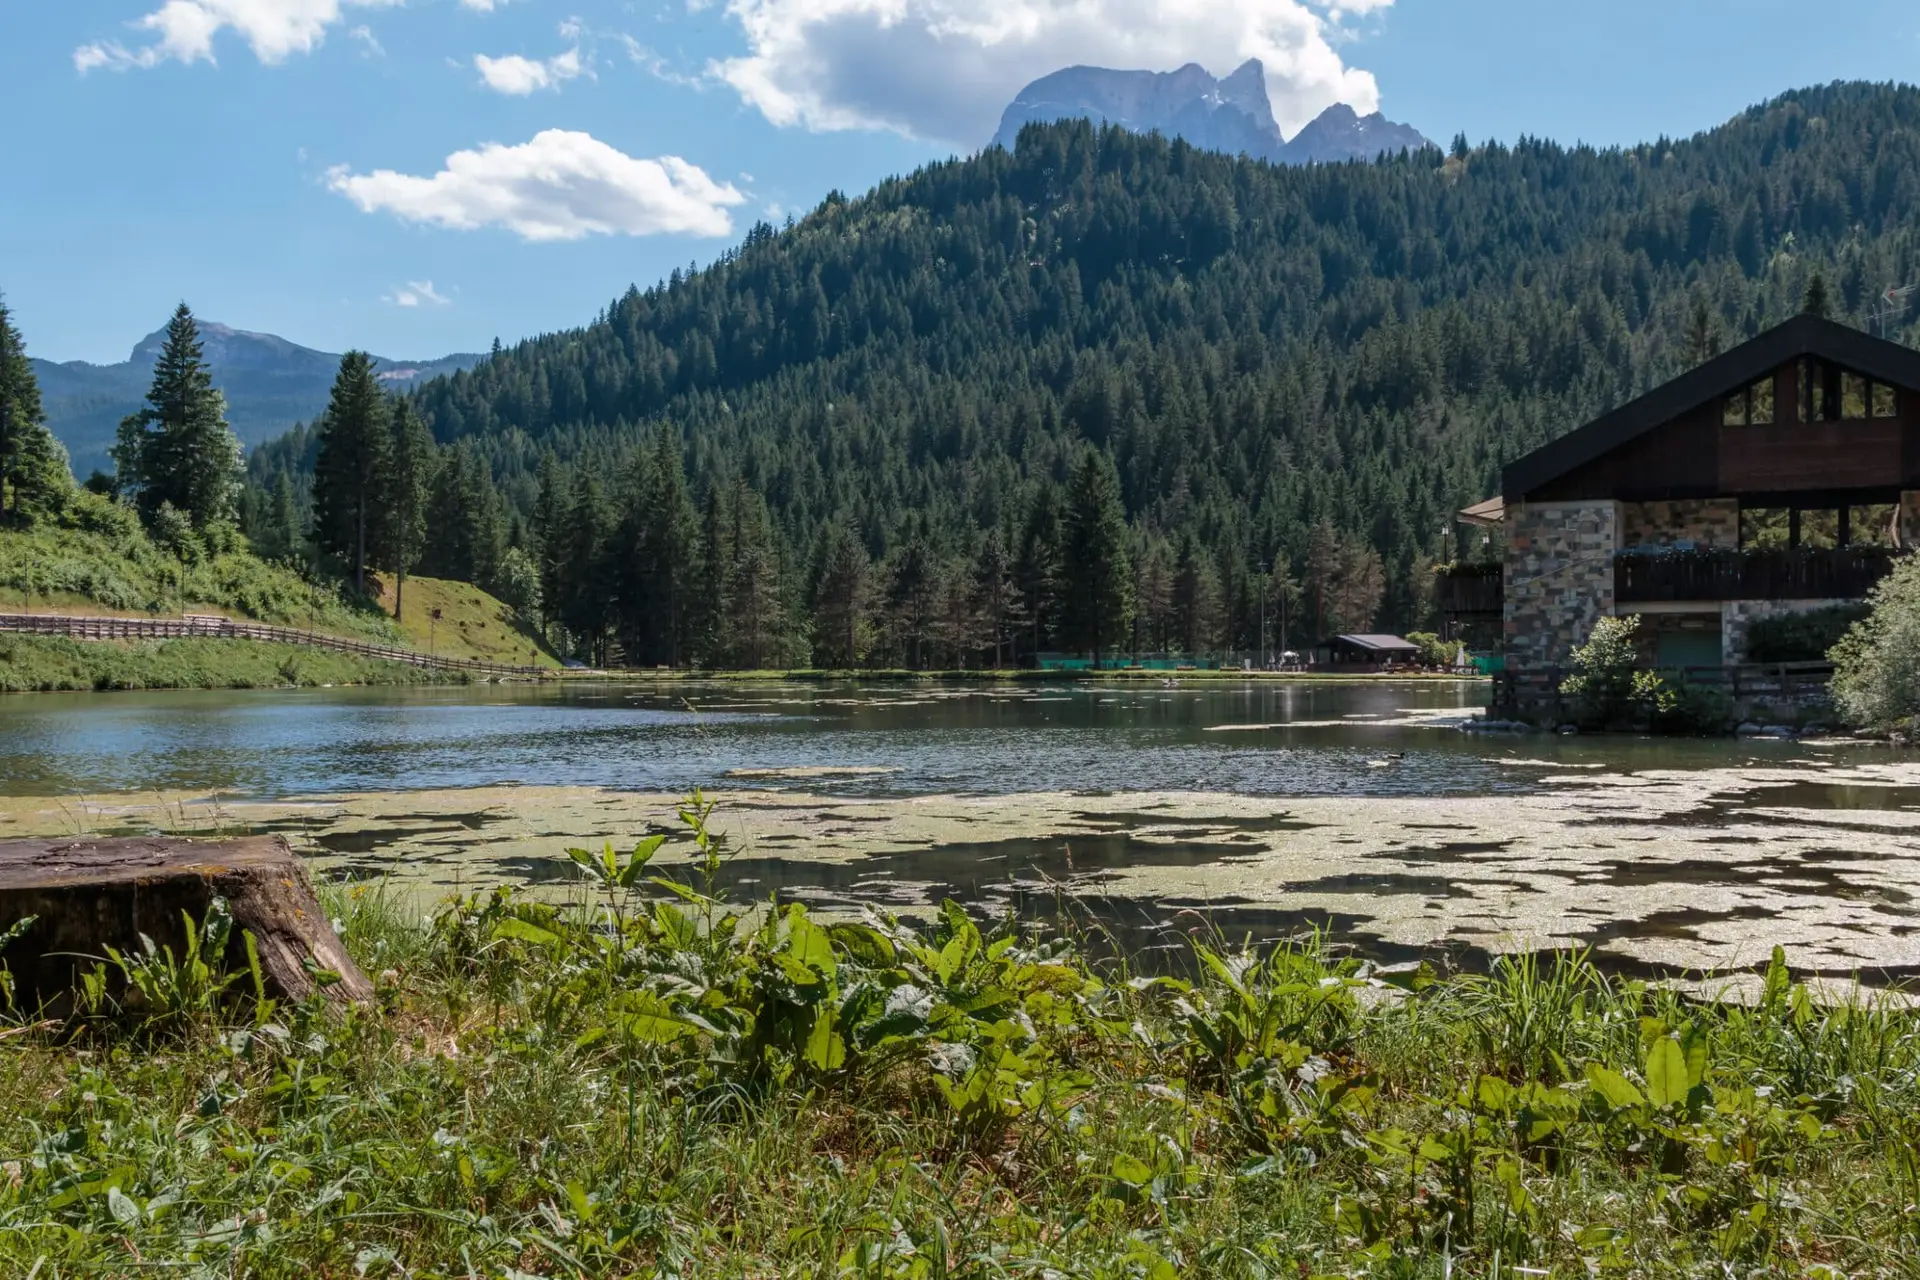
[{"xmin": 326, "ymin": 129, "xmax": 747, "ymax": 240}]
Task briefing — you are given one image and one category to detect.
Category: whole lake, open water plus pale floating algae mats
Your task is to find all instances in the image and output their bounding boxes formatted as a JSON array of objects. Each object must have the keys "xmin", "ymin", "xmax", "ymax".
[{"xmin": 0, "ymin": 681, "xmax": 1920, "ymax": 981}]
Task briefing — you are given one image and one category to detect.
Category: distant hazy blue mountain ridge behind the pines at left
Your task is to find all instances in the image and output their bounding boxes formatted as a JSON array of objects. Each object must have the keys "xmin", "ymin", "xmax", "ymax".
[{"xmin": 33, "ymin": 320, "xmax": 482, "ymax": 478}]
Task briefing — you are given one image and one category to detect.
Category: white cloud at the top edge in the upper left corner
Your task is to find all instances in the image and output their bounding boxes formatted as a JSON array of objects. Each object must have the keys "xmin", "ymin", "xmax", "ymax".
[{"xmin": 73, "ymin": 0, "xmax": 401, "ymax": 73}]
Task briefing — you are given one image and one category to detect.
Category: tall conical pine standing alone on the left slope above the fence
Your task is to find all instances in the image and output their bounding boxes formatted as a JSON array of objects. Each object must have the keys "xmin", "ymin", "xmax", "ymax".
[{"xmin": 113, "ymin": 303, "xmax": 240, "ymax": 532}]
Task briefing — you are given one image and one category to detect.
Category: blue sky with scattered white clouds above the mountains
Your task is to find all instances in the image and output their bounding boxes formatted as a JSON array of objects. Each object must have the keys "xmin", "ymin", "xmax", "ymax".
[{"xmin": 0, "ymin": 0, "xmax": 1920, "ymax": 361}]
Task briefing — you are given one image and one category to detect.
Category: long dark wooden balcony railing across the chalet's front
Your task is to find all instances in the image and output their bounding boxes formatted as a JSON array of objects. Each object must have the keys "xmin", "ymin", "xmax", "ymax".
[{"xmin": 1613, "ymin": 547, "xmax": 1901, "ymax": 604}]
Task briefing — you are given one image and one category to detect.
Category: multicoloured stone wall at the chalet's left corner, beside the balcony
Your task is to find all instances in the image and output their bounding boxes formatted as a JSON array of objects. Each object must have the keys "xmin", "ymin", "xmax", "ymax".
[{"xmin": 1505, "ymin": 499, "xmax": 1620, "ymax": 674}]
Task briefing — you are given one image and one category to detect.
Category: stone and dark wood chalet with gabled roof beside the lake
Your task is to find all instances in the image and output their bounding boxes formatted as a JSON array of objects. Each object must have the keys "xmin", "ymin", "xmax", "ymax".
[{"xmin": 1440, "ymin": 317, "xmax": 1920, "ymax": 706}]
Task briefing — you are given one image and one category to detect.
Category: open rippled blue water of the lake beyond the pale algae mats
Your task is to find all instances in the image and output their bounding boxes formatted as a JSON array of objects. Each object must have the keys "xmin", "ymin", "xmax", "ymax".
[{"xmin": 0, "ymin": 681, "xmax": 1873, "ymax": 798}]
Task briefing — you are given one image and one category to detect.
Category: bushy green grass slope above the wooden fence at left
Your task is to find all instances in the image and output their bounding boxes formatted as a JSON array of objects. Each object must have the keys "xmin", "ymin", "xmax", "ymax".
[{"xmin": 0, "ymin": 491, "xmax": 399, "ymax": 643}]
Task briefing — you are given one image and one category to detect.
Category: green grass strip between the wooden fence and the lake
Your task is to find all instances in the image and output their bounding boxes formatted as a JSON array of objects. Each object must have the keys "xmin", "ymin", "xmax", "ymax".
[{"xmin": 0, "ymin": 633, "xmax": 463, "ymax": 693}]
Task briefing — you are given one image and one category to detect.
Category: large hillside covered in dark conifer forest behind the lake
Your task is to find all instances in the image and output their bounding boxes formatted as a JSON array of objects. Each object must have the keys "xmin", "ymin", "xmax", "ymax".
[{"xmin": 248, "ymin": 84, "xmax": 1920, "ymax": 666}]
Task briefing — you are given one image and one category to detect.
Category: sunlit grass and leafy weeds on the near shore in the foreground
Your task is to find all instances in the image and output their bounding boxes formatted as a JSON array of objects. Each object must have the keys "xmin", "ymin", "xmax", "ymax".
[{"xmin": 0, "ymin": 804, "xmax": 1920, "ymax": 1280}]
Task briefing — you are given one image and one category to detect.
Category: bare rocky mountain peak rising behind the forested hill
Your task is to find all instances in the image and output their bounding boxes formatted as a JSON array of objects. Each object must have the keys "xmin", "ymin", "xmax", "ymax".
[{"xmin": 993, "ymin": 58, "xmax": 1428, "ymax": 165}]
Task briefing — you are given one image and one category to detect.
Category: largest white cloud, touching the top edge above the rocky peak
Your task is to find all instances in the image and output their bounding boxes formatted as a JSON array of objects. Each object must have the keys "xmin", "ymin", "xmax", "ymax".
[{"xmin": 708, "ymin": 0, "xmax": 1392, "ymax": 148}]
